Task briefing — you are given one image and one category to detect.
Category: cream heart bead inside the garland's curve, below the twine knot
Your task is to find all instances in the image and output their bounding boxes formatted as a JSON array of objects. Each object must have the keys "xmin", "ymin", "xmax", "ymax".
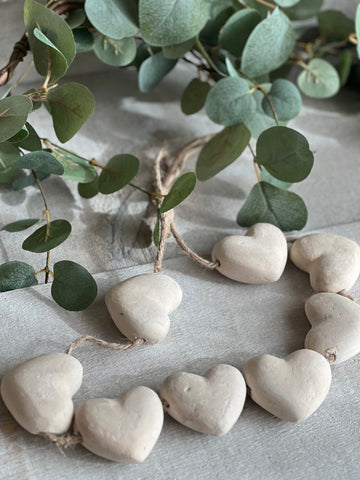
[{"xmin": 105, "ymin": 273, "xmax": 182, "ymax": 344}]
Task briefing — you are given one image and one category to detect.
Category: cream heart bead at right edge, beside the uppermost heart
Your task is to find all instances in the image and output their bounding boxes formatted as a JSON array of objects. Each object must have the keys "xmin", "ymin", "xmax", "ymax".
[{"xmin": 290, "ymin": 233, "xmax": 360, "ymax": 293}]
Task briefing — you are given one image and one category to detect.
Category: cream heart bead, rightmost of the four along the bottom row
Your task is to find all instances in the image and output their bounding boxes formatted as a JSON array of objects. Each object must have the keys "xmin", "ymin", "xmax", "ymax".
[{"xmin": 243, "ymin": 349, "xmax": 331, "ymax": 422}]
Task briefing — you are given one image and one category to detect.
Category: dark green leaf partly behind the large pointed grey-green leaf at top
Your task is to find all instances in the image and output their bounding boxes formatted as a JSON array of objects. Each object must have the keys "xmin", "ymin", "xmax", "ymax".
[{"xmin": 219, "ymin": 8, "xmax": 261, "ymax": 57}]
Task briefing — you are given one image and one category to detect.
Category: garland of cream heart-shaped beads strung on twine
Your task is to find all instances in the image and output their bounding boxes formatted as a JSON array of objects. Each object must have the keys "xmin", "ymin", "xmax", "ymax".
[{"xmin": 0, "ymin": 223, "xmax": 360, "ymax": 463}]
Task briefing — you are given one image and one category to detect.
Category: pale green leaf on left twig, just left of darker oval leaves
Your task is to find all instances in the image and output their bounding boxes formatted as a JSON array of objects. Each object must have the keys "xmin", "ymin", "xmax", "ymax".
[{"xmin": 52, "ymin": 148, "xmax": 97, "ymax": 183}]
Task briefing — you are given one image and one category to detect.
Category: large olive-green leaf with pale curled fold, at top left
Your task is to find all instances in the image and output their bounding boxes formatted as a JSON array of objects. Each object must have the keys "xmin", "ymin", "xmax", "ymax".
[{"xmin": 24, "ymin": 0, "xmax": 75, "ymax": 83}]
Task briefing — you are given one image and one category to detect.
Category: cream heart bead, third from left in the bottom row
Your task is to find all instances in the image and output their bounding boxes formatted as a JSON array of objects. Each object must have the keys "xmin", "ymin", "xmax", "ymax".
[{"xmin": 160, "ymin": 365, "xmax": 246, "ymax": 436}]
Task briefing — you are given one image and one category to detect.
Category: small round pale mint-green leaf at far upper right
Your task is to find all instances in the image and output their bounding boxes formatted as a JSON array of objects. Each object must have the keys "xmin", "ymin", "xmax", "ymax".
[{"xmin": 297, "ymin": 58, "xmax": 340, "ymax": 98}]
